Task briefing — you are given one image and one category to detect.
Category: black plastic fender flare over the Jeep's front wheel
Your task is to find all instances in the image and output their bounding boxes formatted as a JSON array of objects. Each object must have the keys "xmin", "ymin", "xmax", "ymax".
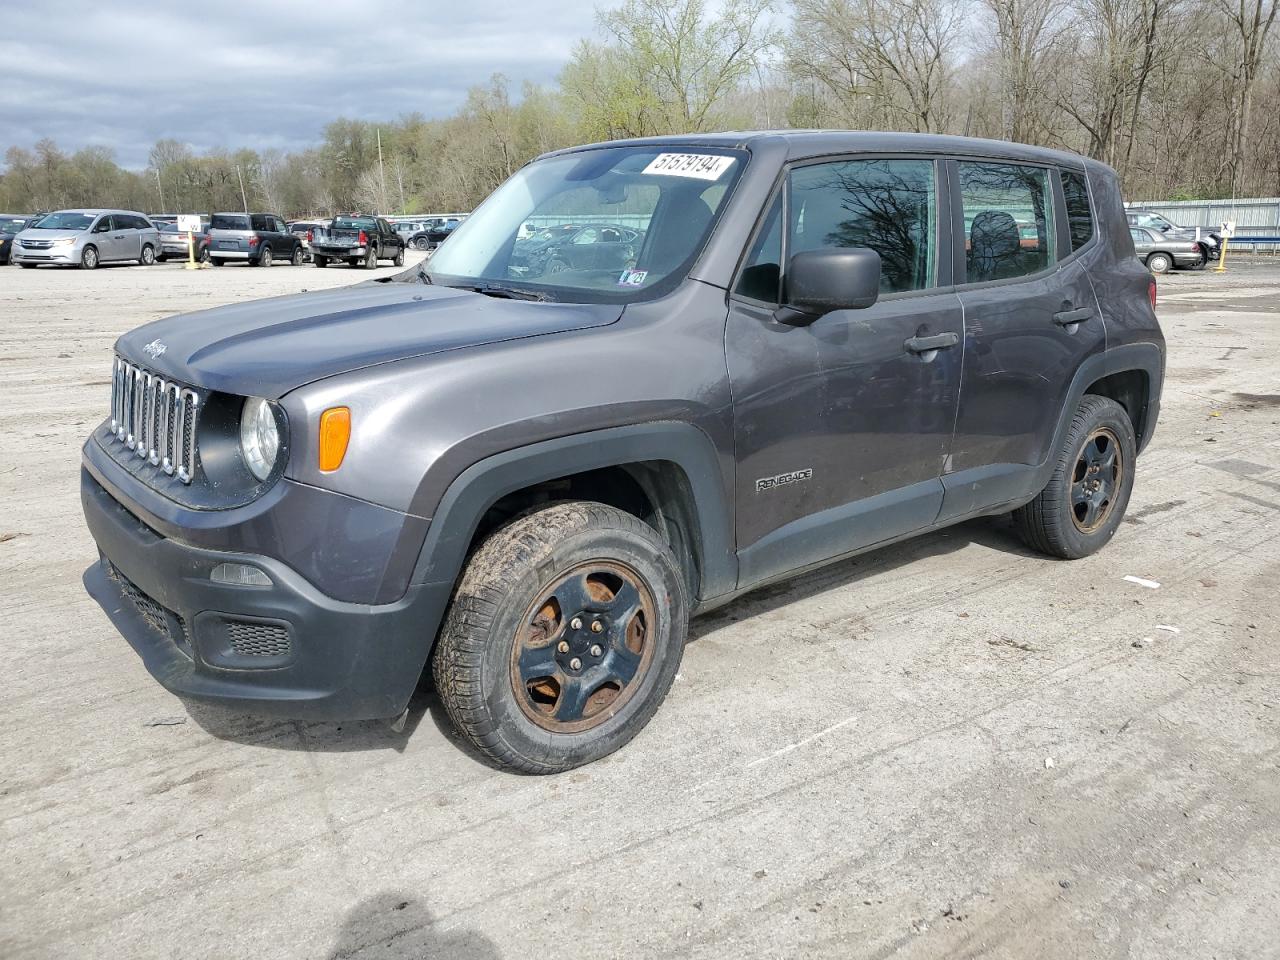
[{"xmin": 412, "ymin": 421, "xmax": 737, "ymax": 600}]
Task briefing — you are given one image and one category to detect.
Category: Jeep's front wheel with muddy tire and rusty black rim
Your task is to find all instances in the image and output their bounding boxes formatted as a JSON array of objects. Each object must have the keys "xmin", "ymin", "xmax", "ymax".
[{"xmin": 431, "ymin": 500, "xmax": 689, "ymax": 773}]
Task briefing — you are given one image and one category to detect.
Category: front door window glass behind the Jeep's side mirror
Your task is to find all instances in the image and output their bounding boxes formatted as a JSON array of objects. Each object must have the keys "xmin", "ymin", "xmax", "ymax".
[{"xmin": 787, "ymin": 160, "xmax": 937, "ymax": 293}]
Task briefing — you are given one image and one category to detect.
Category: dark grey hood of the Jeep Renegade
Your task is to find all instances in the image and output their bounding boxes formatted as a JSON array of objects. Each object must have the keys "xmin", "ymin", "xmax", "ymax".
[{"xmin": 115, "ymin": 283, "xmax": 622, "ymax": 399}]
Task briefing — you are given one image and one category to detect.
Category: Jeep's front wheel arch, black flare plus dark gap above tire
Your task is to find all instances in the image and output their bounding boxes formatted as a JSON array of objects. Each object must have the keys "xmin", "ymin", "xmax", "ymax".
[{"xmin": 412, "ymin": 422, "xmax": 737, "ymax": 611}]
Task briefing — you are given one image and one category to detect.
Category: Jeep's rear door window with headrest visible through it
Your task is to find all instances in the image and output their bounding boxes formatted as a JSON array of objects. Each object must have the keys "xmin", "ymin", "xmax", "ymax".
[{"xmin": 959, "ymin": 160, "xmax": 1053, "ymax": 283}]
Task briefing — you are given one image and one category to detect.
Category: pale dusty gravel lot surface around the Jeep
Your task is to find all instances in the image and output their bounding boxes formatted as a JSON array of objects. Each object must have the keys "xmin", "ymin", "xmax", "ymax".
[{"xmin": 0, "ymin": 261, "xmax": 1280, "ymax": 960}]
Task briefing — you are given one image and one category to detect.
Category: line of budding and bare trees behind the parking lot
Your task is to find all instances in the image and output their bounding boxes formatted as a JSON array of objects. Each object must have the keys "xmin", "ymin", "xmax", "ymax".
[{"xmin": 0, "ymin": 0, "xmax": 1280, "ymax": 216}]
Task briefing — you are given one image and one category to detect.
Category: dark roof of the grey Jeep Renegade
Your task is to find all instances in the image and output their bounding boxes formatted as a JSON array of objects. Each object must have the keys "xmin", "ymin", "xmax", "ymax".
[{"xmin": 545, "ymin": 131, "xmax": 1084, "ymax": 166}]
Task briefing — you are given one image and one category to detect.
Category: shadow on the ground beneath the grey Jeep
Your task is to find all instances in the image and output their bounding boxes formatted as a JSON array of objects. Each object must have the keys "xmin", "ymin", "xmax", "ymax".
[{"xmin": 183, "ymin": 517, "xmax": 1044, "ymax": 768}]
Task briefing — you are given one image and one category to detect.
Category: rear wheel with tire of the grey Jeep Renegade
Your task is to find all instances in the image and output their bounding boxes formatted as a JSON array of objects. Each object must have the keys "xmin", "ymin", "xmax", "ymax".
[{"xmin": 1014, "ymin": 394, "xmax": 1138, "ymax": 559}]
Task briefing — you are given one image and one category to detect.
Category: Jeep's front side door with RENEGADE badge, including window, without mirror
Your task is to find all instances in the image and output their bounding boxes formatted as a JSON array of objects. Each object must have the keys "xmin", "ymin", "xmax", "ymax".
[{"xmin": 726, "ymin": 159, "xmax": 964, "ymax": 586}]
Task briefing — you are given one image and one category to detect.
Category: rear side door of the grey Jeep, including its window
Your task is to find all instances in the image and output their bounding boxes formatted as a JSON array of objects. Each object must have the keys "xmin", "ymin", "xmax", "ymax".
[{"xmin": 942, "ymin": 159, "xmax": 1106, "ymax": 518}]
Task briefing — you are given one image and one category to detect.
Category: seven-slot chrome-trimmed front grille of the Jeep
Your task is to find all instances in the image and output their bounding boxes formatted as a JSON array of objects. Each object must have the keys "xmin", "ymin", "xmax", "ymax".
[{"xmin": 111, "ymin": 357, "xmax": 201, "ymax": 484}]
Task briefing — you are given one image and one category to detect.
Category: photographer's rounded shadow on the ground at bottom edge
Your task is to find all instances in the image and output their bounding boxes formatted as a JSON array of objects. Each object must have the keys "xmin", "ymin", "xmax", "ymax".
[{"xmin": 325, "ymin": 890, "xmax": 502, "ymax": 960}]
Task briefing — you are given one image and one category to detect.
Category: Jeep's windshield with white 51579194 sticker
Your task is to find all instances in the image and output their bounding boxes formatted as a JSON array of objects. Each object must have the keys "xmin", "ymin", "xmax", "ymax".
[{"xmin": 428, "ymin": 146, "xmax": 745, "ymax": 302}]
